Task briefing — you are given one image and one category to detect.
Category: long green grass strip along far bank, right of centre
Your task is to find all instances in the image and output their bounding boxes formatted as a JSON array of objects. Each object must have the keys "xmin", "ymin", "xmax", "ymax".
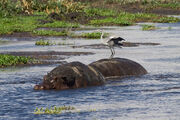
[{"xmin": 89, "ymin": 12, "xmax": 180, "ymax": 26}]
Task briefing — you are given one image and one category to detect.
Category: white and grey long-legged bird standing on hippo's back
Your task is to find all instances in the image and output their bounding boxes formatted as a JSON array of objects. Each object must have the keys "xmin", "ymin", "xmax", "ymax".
[{"xmin": 100, "ymin": 30, "xmax": 125, "ymax": 59}]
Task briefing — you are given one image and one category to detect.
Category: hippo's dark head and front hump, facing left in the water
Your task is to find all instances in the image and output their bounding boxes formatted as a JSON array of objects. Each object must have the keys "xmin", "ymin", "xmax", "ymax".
[{"xmin": 34, "ymin": 62, "xmax": 105, "ymax": 90}]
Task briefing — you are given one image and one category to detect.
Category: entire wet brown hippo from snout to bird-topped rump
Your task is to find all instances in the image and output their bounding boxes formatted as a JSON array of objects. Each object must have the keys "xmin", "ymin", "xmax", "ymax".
[{"xmin": 34, "ymin": 58, "xmax": 147, "ymax": 90}]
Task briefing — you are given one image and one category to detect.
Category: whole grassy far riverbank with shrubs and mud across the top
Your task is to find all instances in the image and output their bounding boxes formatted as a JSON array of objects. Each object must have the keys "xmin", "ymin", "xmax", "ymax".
[{"xmin": 0, "ymin": 0, "xmax": 180, "ymax": 38}]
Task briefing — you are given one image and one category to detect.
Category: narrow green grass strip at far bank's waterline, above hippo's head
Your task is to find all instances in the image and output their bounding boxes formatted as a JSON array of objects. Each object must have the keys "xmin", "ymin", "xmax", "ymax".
[{"xmin": 32, "ymin": 30, "xmax": 68, "ymax": 36}]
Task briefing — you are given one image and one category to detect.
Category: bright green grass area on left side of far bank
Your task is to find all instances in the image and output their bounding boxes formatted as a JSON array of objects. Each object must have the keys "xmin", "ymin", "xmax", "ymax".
[{"xmin": 0, "ymin": 16, "xmax": 79, "ymax": 36}]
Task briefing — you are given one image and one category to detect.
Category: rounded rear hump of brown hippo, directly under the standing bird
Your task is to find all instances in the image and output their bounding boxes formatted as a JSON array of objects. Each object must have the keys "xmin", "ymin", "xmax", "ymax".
[{"xmin": 89, "ymin": 58, "xmax": 147, "ymax": 77}]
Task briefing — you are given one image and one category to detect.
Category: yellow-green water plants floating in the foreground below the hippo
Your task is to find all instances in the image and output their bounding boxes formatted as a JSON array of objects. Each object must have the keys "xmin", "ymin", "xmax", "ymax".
[{"xmin": 34, "ymin": 106, "xmax": 75, "ymax": 114}]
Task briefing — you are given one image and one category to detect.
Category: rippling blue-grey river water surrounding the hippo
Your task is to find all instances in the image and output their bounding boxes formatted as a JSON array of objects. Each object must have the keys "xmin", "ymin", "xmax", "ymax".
[{"xmin": 0, "ymin": 23, "xmax": 180, "ymax": 120}]
